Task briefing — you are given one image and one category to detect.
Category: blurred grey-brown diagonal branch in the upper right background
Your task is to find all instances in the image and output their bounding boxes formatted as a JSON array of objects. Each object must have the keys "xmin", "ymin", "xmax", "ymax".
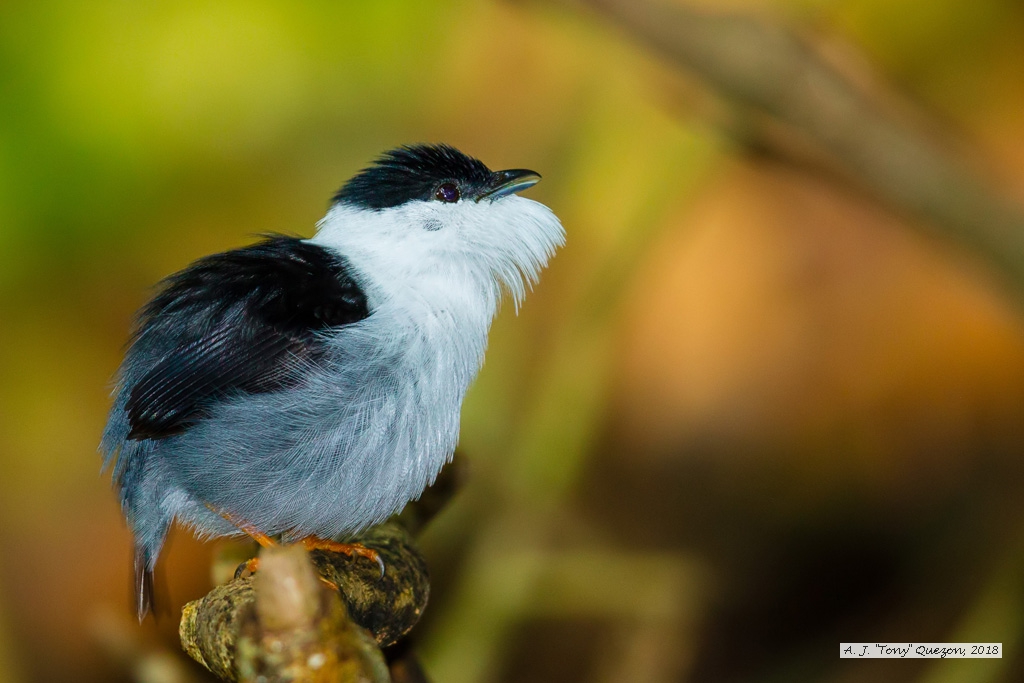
[{"xmin": 583, "ymin": 0, "xmax": 1024, "ymax": 291}]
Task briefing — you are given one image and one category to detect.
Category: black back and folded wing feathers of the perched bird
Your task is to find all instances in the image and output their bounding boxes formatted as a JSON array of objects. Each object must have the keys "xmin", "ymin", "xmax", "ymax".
[{"xmin": 126, "ymin": 236, "xmax": 369, "ymax": 439}]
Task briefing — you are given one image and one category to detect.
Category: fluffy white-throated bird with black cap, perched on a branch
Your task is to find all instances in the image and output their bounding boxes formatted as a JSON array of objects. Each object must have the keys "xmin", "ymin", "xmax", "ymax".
[{"xmin": 100, "ymin": 144, "xmax": 564, "ymax": 620}]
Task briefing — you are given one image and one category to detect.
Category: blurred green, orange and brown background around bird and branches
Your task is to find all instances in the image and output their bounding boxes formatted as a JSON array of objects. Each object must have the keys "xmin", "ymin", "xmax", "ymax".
[{"xmin": 0, "ymin": 0, "xmax": 1024, "ymax": 683}]
